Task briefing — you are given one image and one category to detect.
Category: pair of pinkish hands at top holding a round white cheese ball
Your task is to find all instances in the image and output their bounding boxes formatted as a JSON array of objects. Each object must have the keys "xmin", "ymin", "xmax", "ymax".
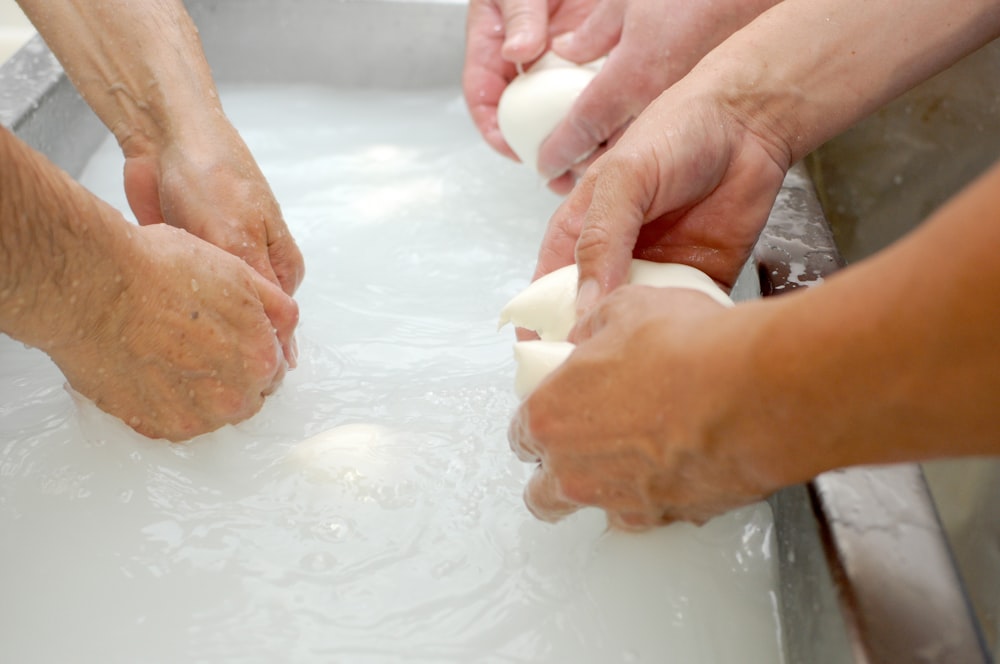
[{"xmin": 462, "ymin": 0, "xmax": 776, "ymax": 194}]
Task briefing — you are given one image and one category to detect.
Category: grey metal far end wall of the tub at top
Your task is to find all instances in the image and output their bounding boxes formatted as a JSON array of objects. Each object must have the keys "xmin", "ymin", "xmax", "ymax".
[{"xmin": 184, "ymin": 0, "xmax": 468, "ymax": 90}]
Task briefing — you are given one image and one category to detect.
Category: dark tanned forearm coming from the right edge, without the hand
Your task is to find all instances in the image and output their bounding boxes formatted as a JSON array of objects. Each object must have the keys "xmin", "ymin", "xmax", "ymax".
[{"xmin": 727, "ymin": 159, "xmax": 1000, "ymax": 484}]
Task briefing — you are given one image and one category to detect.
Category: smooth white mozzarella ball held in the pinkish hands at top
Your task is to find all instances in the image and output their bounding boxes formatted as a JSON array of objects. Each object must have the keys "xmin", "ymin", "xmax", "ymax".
[{"xmin": 497, "ymin": 52, "xmax": 604, "ymax": 169}]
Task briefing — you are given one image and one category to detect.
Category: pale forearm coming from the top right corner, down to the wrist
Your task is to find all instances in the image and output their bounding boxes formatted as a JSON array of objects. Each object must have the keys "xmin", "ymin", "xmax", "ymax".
[{"xmin": 695, "ymin": 0, "xmax": 1000, "ymax": 162}]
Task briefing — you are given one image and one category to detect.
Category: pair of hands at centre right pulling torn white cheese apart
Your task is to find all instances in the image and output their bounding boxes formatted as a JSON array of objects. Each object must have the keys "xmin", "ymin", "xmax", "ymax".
[{"xmin": 510, "ymin": 75, "xmax": 790, "ymax": 529}]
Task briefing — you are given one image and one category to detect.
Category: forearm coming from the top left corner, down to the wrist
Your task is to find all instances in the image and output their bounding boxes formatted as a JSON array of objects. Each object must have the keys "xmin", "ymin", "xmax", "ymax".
[{"xmin": 19, "ymin": 0, "xmax": 221, "ymax": 156}]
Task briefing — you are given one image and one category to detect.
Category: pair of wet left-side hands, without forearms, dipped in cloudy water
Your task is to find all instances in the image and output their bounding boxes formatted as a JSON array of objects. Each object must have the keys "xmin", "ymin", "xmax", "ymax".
[{"xmin": 72, "ymin": 113, "xmax": 304, "ymax": 440}]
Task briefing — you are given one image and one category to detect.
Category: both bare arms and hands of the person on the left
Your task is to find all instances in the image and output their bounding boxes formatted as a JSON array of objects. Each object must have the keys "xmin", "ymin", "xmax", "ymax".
[{"xmin": 0, "ymin": 0, "xmax": 304, "ymax": 440}]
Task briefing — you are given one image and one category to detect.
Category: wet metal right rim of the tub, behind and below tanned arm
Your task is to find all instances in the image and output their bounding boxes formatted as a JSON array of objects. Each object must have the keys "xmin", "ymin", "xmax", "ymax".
[{"xmin": 753, "ymin": 164, "xmax": 991, "ymax": 664}]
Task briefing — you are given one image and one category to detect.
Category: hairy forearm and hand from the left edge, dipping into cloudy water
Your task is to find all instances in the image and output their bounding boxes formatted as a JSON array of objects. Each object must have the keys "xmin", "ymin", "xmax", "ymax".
[{"xmin": 0, "ymin": 121, "xmax": 298, "ymax": 440}]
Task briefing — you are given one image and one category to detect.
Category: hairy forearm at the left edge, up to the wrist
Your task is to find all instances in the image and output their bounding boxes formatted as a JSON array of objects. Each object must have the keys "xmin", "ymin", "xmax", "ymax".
[{"xmin": 0, "ymin": 128, "xmax": 125, "ymax": 352}]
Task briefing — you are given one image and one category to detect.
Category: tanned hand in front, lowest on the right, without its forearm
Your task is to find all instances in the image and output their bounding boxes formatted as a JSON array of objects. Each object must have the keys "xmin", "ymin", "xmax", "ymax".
[{"xmin": 509, "ymin": 286, "xmax": 778, "ymax": 530}]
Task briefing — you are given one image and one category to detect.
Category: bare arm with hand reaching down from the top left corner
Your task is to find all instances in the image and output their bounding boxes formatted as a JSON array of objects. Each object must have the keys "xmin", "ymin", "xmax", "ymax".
[{"xmin": 19, "ymin": 0, "xmax": 304, "ymax": 294}]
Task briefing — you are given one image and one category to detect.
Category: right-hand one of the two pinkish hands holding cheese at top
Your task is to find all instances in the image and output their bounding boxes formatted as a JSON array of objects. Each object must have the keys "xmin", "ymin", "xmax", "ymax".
[{"xmin": 539, "ymin": 0, "xmax": 776, "ymax": 194}]
